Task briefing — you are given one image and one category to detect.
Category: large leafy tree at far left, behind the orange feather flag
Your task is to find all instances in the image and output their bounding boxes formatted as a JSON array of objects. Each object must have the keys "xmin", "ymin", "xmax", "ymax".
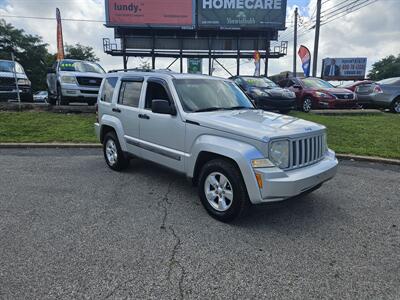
[{"xmin": 0, "ymin": 19, "xmax": 53, "ymax": 90}]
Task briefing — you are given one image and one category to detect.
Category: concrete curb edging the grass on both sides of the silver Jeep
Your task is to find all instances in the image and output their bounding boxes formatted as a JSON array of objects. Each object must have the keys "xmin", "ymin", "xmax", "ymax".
[{"xmin": 0, "ymin": 143, "xmax": 400, "ymax": 166}]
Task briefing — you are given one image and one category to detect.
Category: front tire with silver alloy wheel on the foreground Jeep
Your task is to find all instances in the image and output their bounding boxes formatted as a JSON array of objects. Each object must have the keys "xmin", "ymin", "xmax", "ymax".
[{"xmin": 198, "ymin": 159, "xmax": 250, "ymax": 222}]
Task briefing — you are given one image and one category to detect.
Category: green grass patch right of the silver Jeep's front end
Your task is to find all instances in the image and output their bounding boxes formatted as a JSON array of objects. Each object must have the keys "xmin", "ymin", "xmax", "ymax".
[{"xmin": 291, "ymin": 112, "xmax": 400, "ymax": 159}]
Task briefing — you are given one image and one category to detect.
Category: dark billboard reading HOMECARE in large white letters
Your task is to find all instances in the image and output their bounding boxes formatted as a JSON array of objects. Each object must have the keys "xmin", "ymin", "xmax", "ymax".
[{"xmin": 197, "ymin": 0, "xmax": 287, "ymax": 29}]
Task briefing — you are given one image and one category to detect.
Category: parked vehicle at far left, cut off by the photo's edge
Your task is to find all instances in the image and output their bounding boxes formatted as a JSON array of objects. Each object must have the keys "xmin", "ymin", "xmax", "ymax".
[{"xmin": 0, "ymin": 60, "xmax": 33, "ymax": 102}]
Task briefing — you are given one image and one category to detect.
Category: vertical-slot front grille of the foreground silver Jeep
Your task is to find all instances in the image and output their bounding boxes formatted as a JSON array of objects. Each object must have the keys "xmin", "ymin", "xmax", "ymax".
[{"xmin": 288, "ymin": 134, "xmax": 324, "ymax": 169}]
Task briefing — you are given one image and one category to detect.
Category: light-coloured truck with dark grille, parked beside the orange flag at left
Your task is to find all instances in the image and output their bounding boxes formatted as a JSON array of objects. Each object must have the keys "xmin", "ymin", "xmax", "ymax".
[{"xmin": 47, "ymin": 59, "xmax": 105, "ymax": 105}]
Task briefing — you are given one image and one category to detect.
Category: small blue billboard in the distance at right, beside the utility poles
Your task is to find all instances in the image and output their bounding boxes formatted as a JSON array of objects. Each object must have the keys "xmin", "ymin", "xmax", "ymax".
[{"xmin": 321, "ymin": 57, "xmax": 367, "ymax": 80}]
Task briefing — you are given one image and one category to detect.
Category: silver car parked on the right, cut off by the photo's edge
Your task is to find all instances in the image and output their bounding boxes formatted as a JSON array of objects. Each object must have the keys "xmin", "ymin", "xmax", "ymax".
[{"xmin": 356, "ymin": 77, "xmax": 400, "ymax": 113}]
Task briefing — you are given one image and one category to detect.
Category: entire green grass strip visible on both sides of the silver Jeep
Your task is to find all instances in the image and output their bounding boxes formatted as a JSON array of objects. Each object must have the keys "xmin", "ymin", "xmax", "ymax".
[{"xmin": 0, "ymin": 112, "xmax": 400, "ymax": 159}]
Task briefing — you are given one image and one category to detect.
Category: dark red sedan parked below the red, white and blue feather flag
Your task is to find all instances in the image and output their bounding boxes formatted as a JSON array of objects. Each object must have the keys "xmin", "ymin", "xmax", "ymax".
[{"xmin": 279, "ymin": 77, "xmax": 359, "ymax": 112}]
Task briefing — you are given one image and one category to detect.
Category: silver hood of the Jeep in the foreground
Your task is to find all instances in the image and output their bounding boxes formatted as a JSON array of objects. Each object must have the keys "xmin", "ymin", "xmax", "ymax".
[{"xmin": 187, "ymin": 110, "xmax": 325, "ymax": 142}]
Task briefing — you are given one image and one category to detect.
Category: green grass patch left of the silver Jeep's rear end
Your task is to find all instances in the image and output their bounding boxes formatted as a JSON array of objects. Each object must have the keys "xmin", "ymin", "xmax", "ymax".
[{"xmin": 0, "ymin": 112, "xmax": 97, "ymax": 143}]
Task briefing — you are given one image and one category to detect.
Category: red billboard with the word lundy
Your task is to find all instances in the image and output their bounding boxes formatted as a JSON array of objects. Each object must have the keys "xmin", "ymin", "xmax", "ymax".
[{"xmin": 105, "ymin": 0, "xmax": 194, "ymax": 28}]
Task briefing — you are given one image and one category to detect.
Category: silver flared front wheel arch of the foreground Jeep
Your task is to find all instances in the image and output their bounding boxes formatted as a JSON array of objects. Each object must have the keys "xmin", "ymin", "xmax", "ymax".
[{"xmin": 186, "ymin": 135, "xmax": 264, "ymax": 202}]
